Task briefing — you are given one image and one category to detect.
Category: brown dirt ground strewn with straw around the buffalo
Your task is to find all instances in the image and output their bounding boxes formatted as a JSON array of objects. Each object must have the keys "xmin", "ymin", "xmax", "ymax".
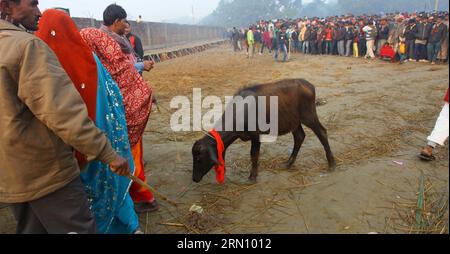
[{"xmin": 0, "ymin": 46, "xmax": 449, "ymax": 234}]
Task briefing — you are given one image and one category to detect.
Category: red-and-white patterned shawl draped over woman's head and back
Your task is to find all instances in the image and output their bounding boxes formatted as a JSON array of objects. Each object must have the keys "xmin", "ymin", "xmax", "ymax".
[{"xmin": 80, "ymin": 28, "xmax": 152, "ymax": 147}]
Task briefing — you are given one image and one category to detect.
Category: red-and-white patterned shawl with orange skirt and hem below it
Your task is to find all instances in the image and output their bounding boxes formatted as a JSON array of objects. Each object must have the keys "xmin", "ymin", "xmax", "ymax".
[{"xmin": 80, "ymin": 28, "xmax": 155, "ymax": 203}]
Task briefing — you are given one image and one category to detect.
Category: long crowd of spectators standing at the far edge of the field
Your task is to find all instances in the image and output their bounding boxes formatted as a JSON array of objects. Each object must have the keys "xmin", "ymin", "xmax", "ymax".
[{"xmin": 230, "ymin": 12, "xmax": 449, "ymax": 64}]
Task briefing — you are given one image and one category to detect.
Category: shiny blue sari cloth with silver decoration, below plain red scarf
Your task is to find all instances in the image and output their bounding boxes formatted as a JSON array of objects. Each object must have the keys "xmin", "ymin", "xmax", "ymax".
[{"xmin": 81, "ymin": 54, "xmax": 139, "ymax": 234}]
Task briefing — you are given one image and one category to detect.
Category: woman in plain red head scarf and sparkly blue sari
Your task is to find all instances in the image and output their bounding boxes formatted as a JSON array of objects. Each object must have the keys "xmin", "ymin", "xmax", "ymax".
[{"xmin": 36, "ymin": 10, "xmax": 139, "ymax": 234}]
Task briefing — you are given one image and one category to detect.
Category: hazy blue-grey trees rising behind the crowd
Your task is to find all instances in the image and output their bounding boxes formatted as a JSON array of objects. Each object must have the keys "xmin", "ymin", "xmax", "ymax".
[{"xmin": 201, "ymin": 0, "xmax": 449, "ymax": 27}]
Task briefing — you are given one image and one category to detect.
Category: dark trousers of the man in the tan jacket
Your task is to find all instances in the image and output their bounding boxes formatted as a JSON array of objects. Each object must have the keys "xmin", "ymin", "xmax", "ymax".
[{"xmin": 11, "ymin": 177, "xmax": 97, "ymax": 234}]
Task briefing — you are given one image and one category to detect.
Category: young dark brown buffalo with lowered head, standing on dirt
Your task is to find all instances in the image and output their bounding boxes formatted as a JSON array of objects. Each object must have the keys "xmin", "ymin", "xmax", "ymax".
[{"xmin": 192, "ymin": 79, "xmax": 336, "ymax": 182}]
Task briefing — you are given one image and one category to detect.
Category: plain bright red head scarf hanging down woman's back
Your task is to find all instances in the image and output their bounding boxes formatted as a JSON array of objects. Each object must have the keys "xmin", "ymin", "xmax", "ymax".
[{"xmin": 36, "ymin": 10, "xmax": 97, "ymax": 121}]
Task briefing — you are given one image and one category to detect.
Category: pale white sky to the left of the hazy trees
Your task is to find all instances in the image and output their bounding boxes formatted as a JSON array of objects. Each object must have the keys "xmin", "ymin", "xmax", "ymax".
[{"xmin": 39, "ymin": 0, "xmax": 220, "ymax": 22}]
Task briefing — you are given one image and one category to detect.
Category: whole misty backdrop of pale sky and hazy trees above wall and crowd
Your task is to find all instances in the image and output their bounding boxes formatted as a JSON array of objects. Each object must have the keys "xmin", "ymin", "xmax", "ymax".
[{"xmin": 39, "ymin": 0, "xmax": 449, "ymax": 28}]
